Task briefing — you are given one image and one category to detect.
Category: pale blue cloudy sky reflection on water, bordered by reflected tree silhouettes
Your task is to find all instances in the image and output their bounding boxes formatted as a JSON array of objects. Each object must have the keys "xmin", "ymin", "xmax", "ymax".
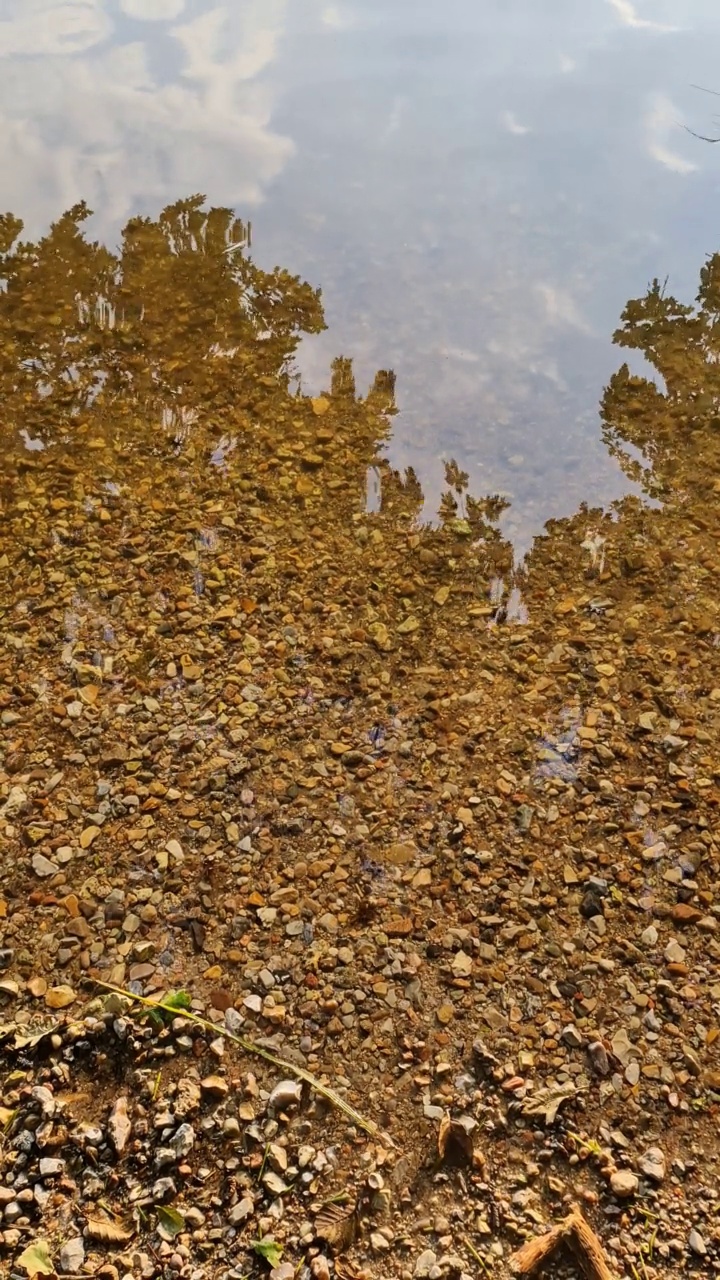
[{"xmin": 0, "ymin": 0, "xmax": 720, "ymax": 550}]
